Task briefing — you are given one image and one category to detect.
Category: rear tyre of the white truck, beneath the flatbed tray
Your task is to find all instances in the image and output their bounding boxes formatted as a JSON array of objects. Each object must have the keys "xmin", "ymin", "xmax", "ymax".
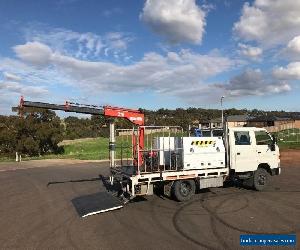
[{"xmin": 172, "ymin": 180, "xmax": 196, "ymax": 201}]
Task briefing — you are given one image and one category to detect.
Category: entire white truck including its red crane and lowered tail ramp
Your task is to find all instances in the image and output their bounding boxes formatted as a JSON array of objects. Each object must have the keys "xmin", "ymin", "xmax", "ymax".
[{"xmin": 12, "ymin": 97, "xmax": 280, "ymax": 217}]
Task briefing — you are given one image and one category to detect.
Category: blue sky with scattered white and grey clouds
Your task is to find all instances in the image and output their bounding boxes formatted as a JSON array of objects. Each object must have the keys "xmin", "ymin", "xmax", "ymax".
[{"xmin": 0, "ymin": 0, "xmax": 300, "ymax": 114}]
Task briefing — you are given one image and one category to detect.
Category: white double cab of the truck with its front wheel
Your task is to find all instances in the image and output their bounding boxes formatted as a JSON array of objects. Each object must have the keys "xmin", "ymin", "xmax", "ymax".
[{"xmin": 227, "ymin": 127, "xmax": 280, "ymax": 190}]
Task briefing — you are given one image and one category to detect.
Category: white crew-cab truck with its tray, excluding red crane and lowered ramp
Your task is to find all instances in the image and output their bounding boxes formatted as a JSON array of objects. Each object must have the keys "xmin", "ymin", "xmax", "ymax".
[{"xmin": 109, "ymin": 127, "xmax": 281, "ymax": 201}]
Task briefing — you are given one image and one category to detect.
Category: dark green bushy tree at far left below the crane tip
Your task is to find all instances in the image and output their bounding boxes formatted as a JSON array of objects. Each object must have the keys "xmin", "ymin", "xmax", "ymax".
[{"xmin": 0, "ymin": 109, "xmax": 63, "ymax": 156}]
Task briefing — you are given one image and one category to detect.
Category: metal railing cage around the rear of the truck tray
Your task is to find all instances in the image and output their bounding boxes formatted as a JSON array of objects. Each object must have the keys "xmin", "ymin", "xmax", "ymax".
[{"xmin": 116, "ymin": 126, "xmax": 184, "ymax": 174}]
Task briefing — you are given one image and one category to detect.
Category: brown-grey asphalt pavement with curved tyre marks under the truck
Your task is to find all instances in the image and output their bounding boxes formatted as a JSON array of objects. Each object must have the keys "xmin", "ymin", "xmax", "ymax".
[{"xmin": 0, "ymin": 162, "xmax": 300, "ymax": 250}]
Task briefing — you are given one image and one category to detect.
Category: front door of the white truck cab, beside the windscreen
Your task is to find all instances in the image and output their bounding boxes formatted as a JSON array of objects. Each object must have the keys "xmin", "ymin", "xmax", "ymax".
[{"xmin": 254, "ymin": 130, "xmax": 279, "ymax": 168}]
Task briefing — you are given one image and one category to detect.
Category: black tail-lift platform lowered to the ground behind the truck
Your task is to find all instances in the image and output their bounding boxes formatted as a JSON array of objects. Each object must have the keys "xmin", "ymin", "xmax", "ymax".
[{"xmin": 72, "ymin": 191, "xmax": 124, "ymax": 217}]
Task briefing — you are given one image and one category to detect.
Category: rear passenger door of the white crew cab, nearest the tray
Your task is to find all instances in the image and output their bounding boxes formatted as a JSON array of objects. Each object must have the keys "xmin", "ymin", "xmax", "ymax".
[{"xmin": 230, "ymin": 130, "xmax": 257, "ymax": 172}]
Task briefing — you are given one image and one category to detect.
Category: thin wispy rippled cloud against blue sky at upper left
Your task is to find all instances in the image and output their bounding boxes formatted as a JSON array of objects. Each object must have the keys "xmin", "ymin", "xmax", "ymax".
[{"xmin": 24, "ymin": 24, "xmax": 134, "ymax": 60}]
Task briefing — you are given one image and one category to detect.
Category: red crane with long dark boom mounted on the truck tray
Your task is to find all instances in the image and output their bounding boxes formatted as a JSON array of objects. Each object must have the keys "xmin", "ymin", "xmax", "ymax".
[{"xmin": 13, "ymin": 96, "xmax": 145, "ymax": 165}]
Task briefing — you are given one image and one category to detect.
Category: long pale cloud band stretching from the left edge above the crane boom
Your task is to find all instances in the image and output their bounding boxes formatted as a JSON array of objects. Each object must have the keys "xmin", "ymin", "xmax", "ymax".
[{"xmin": 5, "ymin": 40, "xmax": 235, "ymax": 98}]
